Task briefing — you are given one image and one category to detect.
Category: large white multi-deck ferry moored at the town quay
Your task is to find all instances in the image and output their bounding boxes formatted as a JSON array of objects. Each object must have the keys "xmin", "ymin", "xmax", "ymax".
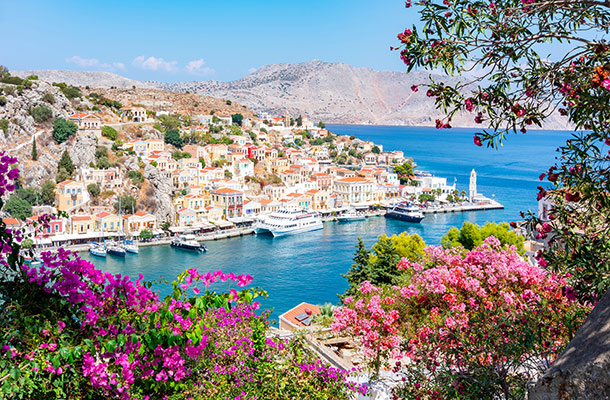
[{"xmin": 254, "ymin": 209, "xmax": 324, "ymax": 236}]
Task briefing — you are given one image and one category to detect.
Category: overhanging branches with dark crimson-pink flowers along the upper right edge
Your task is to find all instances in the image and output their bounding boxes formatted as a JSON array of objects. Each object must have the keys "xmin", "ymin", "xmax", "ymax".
[{"xmin": 398, "ymin": 0, "xmax": 610, "ymax": 300}]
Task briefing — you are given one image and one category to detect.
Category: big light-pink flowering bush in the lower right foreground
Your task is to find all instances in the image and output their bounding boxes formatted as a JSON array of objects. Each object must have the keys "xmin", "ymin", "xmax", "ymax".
[{"xmin": 332, "ymin": 237, "xmax": 591, "ymax": 400}]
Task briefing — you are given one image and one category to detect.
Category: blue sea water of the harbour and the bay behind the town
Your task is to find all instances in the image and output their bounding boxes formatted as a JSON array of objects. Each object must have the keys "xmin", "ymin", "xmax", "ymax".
[{"xmin": 83, "ymin": 125, "xmax": 570, "ymax": 318}]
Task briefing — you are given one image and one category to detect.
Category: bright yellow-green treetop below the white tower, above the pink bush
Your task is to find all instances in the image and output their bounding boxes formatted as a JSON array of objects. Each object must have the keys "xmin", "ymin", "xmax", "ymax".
[{"xmin": 441, "ymin": 222, "xmax": 525, "ymax": 255}]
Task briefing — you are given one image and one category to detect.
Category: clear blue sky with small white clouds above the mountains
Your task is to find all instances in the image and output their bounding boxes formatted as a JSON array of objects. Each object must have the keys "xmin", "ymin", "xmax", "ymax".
[{"xmin": 0, "ymin": 0, "xmax": 417, "ymax": 82}]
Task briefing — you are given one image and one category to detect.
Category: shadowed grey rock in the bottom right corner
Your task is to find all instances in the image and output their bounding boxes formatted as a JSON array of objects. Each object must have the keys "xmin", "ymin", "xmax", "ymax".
[{"xmin": 529, "ymin": 291, "xmax": 610, "ymax": 400}]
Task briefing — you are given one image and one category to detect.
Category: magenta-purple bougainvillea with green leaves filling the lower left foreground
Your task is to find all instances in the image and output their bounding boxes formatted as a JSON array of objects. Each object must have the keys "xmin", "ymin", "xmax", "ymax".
[{"xmin": 0, "ymin": 154, "xmax": 365, "ymax": 400}]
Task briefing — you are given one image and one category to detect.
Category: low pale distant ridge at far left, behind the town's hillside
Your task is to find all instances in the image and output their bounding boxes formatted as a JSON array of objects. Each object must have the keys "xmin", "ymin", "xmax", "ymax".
[{"xmin": 11, "ymin": 69, "xmax": 151, "ymax": 88}]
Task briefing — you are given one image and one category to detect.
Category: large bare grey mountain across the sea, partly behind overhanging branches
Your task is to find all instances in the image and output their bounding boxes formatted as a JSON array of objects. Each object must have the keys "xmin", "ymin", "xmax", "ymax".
[{"xmin": 149, "ymin": 60, "xmax": 564, "ymax": 129}]
